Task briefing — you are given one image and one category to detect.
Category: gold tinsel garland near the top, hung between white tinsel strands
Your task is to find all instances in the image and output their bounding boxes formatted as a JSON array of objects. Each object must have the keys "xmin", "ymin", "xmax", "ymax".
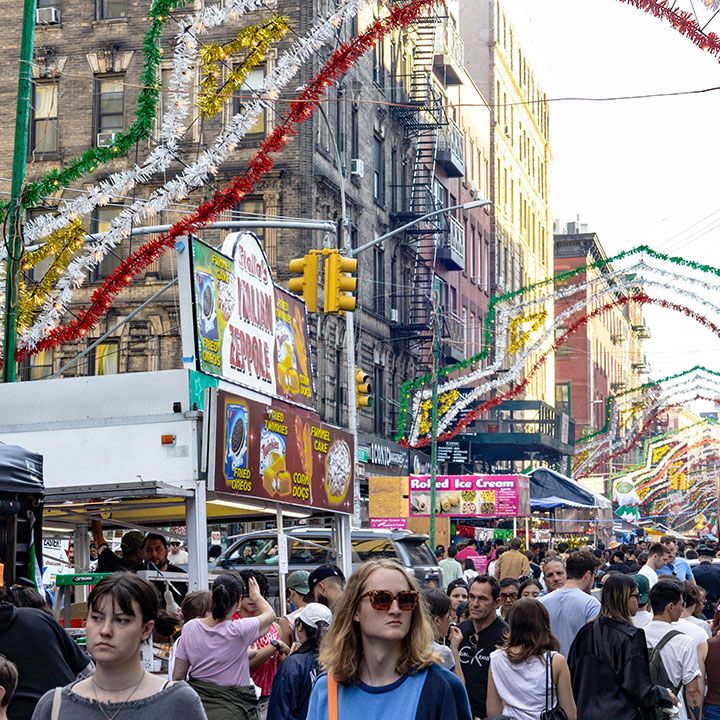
[{"xmin": 197, "ymin": 17, "xmax": 290, "ymax": 117}]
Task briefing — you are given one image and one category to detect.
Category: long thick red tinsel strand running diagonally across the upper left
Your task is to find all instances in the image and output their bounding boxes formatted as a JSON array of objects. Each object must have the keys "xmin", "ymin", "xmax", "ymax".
[{"xmin": 16, "ymin": 0, "xmax": 437, "ymax": 361}]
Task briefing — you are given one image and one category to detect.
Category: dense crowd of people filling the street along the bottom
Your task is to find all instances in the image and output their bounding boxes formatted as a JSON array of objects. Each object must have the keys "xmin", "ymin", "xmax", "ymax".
[{"xmin": 0, "ymin": 537, "xmax": 720, "ymax": 720}]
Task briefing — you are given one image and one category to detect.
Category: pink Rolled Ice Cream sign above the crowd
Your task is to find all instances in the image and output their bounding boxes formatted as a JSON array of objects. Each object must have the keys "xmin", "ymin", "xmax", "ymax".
[{"xmin": 408, "ymin": 475, "xmax": 530, "ymax": 517}]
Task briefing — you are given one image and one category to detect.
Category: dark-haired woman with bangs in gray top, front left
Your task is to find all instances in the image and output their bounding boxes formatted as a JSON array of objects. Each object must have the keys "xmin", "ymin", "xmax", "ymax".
[{"xmin": 33, "ymin": 573, "xmax": 206, "ymax": 720}]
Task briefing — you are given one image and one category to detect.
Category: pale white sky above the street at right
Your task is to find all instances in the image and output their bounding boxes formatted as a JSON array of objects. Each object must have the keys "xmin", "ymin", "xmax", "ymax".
[{"xmin": 504, "ymin": 0, "xmax": 720, "ymax": 379}]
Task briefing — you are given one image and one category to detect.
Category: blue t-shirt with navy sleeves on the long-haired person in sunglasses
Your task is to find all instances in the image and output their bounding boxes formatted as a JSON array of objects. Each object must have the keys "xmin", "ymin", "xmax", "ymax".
[{"xmin": 307, "ymin": 665, "xmax": 471, "ymax": 720}]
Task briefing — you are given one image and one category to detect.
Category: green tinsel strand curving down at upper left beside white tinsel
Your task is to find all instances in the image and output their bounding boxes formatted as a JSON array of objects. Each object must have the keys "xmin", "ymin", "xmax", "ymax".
[{"xmin": 0, "ymin": 0, "xmax": 188, "ymax": 213}]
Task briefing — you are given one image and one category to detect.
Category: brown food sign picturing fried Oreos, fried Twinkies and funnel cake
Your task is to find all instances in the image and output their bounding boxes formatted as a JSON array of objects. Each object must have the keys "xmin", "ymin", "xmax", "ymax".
[{"xmin": 209, "ymin": 390, "xmax": 354, "ymax": 513}]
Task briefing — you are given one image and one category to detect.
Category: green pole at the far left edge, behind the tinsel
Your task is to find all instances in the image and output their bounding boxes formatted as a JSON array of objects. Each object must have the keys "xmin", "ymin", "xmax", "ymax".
[{"xmin": 2, "ymin": 0, "xmax": 37, "ymax": 382}]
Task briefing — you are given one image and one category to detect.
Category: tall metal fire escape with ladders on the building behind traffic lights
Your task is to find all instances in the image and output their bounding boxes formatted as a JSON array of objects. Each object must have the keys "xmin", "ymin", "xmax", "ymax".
[{"xmin": 390, "ymin": 7, "xmax": 464, "ymax": 356}]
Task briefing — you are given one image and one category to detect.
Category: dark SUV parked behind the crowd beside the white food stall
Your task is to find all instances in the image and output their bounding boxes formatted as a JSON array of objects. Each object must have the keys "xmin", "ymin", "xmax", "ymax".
[{"xmin": 215, "ymin": 527, "xmax": 442, "ymax": 596}]
